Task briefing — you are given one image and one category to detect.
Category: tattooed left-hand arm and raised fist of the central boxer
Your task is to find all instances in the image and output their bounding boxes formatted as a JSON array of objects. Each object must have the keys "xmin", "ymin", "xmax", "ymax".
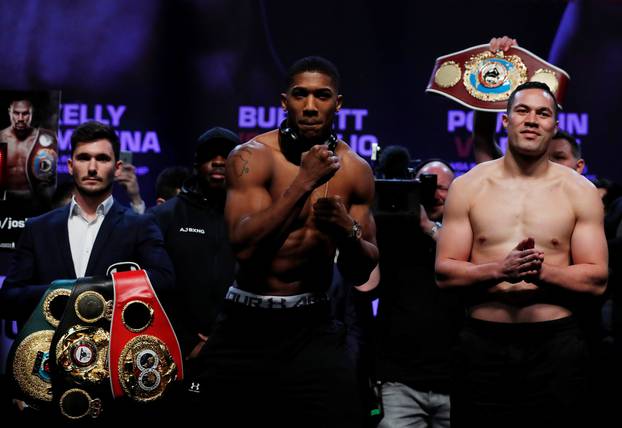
[{"xmin": 225, "ymin": 141, "xmax": 340, "ymax": 261}]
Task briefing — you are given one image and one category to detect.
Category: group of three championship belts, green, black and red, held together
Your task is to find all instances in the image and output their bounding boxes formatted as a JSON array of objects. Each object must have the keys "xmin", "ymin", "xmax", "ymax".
[{"xmin": 8, "ymin": 263, "xmax": 183, "ymax": 422}]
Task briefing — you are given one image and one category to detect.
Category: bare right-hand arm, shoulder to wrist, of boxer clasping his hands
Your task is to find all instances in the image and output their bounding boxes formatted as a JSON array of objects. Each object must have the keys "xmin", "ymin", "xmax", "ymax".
[{"xmin": 540, "ymin": 181, "xmax": 608, "ymax": 295}]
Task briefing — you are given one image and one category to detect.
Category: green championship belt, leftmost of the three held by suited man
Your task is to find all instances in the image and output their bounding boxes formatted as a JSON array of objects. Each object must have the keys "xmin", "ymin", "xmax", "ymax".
[{"xmin": 7, "ymin": 280, "xmax": 75, "ymax": 407}]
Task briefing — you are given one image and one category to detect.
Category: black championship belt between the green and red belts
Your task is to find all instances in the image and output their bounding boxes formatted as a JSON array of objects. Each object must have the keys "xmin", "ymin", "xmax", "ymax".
[{"xmin": 50, "ymin": 277, "xmax": 113, "ymax": 419}]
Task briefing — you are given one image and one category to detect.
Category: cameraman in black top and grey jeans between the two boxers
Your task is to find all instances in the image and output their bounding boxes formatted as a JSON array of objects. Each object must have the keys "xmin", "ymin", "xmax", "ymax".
[{"xmin": 376, "ymin": 158, "xmax": 462, "ymax": 428}]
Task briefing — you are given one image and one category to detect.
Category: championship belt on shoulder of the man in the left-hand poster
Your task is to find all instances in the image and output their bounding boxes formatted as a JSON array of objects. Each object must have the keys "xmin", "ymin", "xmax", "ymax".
[{"xmin": 26, "ymin": 128, "xmax": 58, "ymax": 196}]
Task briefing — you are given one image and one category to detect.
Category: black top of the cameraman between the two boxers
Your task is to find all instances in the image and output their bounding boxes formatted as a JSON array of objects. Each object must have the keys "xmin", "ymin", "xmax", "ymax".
[{"xmin": 376, "ymin": 216, "xmax": 464, "ymax": 392}]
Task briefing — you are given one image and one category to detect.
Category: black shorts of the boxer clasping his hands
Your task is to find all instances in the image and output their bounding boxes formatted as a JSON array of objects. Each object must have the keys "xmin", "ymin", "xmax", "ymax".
[{"xmin": 451, "ymin": 316, "xmax": 590, "ymax": 428}]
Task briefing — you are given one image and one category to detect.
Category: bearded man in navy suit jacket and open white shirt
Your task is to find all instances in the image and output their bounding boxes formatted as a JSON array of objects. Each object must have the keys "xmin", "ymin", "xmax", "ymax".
[{"xmin": 0, "ymin": 121, "xmax": 174, "ymax": 321}]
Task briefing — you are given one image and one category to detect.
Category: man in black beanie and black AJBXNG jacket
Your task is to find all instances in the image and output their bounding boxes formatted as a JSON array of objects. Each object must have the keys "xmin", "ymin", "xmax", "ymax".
[{"xmin": 151, "ymin": 127, "xmax": 240, "ymax": 360}]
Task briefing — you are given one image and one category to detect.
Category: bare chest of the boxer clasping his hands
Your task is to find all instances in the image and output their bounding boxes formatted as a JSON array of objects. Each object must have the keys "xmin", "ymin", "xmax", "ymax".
[{"xmin": 476, "ymin": 182, "xmax": 575, "ymax": 250}]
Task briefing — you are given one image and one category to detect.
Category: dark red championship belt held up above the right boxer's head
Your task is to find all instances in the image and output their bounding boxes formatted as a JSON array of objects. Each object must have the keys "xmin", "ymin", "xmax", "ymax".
[{"xmin": 426, "ymin": 45, "xmax": 570, "ymax": 112}]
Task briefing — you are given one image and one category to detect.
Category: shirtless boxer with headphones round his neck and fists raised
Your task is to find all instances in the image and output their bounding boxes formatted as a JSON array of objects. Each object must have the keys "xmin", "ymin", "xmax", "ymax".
[{"xmin": 190, "ymin": 57, "xmax": 378, "ymax": 427}]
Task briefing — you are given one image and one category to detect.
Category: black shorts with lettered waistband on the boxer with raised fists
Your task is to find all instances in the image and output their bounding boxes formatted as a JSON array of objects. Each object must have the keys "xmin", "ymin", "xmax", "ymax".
[{"xmin": 184, "ymin": 288, "xmax": 362, "ymax": 428}]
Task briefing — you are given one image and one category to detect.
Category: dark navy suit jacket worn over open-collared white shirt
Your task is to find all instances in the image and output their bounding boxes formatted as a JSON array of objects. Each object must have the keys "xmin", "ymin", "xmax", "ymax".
[{"xmin": 0, "ymin": 201, "xmax": 175, "ymax": 321}]
